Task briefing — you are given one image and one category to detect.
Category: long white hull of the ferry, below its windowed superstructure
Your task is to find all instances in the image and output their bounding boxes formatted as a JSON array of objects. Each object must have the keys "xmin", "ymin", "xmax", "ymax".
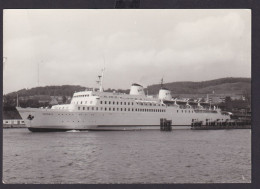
[{"xmin": 17, "ymin": 107, "xmax": 229, "ymax": 131}]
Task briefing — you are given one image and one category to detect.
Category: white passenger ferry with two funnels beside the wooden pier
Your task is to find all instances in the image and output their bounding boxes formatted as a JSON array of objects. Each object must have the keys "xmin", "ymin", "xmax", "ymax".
[{"xmin": 16, "ymin": 71, "xmax": 230, "ymax": 132}]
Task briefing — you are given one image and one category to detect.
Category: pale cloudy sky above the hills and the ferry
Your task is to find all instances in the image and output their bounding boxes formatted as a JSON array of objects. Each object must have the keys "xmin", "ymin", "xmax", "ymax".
[{"xmin": 3, "ymin": 9, "xmax": 251, "ymax": 94}]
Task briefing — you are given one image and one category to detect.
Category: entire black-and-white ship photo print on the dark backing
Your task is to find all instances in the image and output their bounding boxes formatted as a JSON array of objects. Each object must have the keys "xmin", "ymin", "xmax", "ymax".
[{"xmin": 2, "ymin": 9, "xmax": 252, "ymax": 184}]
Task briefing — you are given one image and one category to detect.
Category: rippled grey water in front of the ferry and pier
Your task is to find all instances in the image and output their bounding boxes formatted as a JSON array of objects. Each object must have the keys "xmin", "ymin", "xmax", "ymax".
[{"xmin": 3, "ymin": 129, "xmax": 251, "ymax": 183}]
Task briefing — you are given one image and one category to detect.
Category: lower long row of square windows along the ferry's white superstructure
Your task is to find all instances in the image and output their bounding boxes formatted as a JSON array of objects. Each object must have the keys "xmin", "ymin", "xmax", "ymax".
[{"xmin": 78, "ymin": 107, "xmax": 166, "ymax": 112}]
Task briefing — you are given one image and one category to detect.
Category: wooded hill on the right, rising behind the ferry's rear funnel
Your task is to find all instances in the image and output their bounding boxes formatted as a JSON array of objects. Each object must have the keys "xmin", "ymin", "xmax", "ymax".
[{"xmin": 148, "ymin": 77, "xmax": 251, "ymax": 94}]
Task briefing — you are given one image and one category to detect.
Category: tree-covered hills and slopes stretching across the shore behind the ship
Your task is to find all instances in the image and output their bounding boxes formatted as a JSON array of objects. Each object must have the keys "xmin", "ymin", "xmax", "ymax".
[{"xmin": 3, "ymin": 78, "xmax": 251, "ymax": 119}]
